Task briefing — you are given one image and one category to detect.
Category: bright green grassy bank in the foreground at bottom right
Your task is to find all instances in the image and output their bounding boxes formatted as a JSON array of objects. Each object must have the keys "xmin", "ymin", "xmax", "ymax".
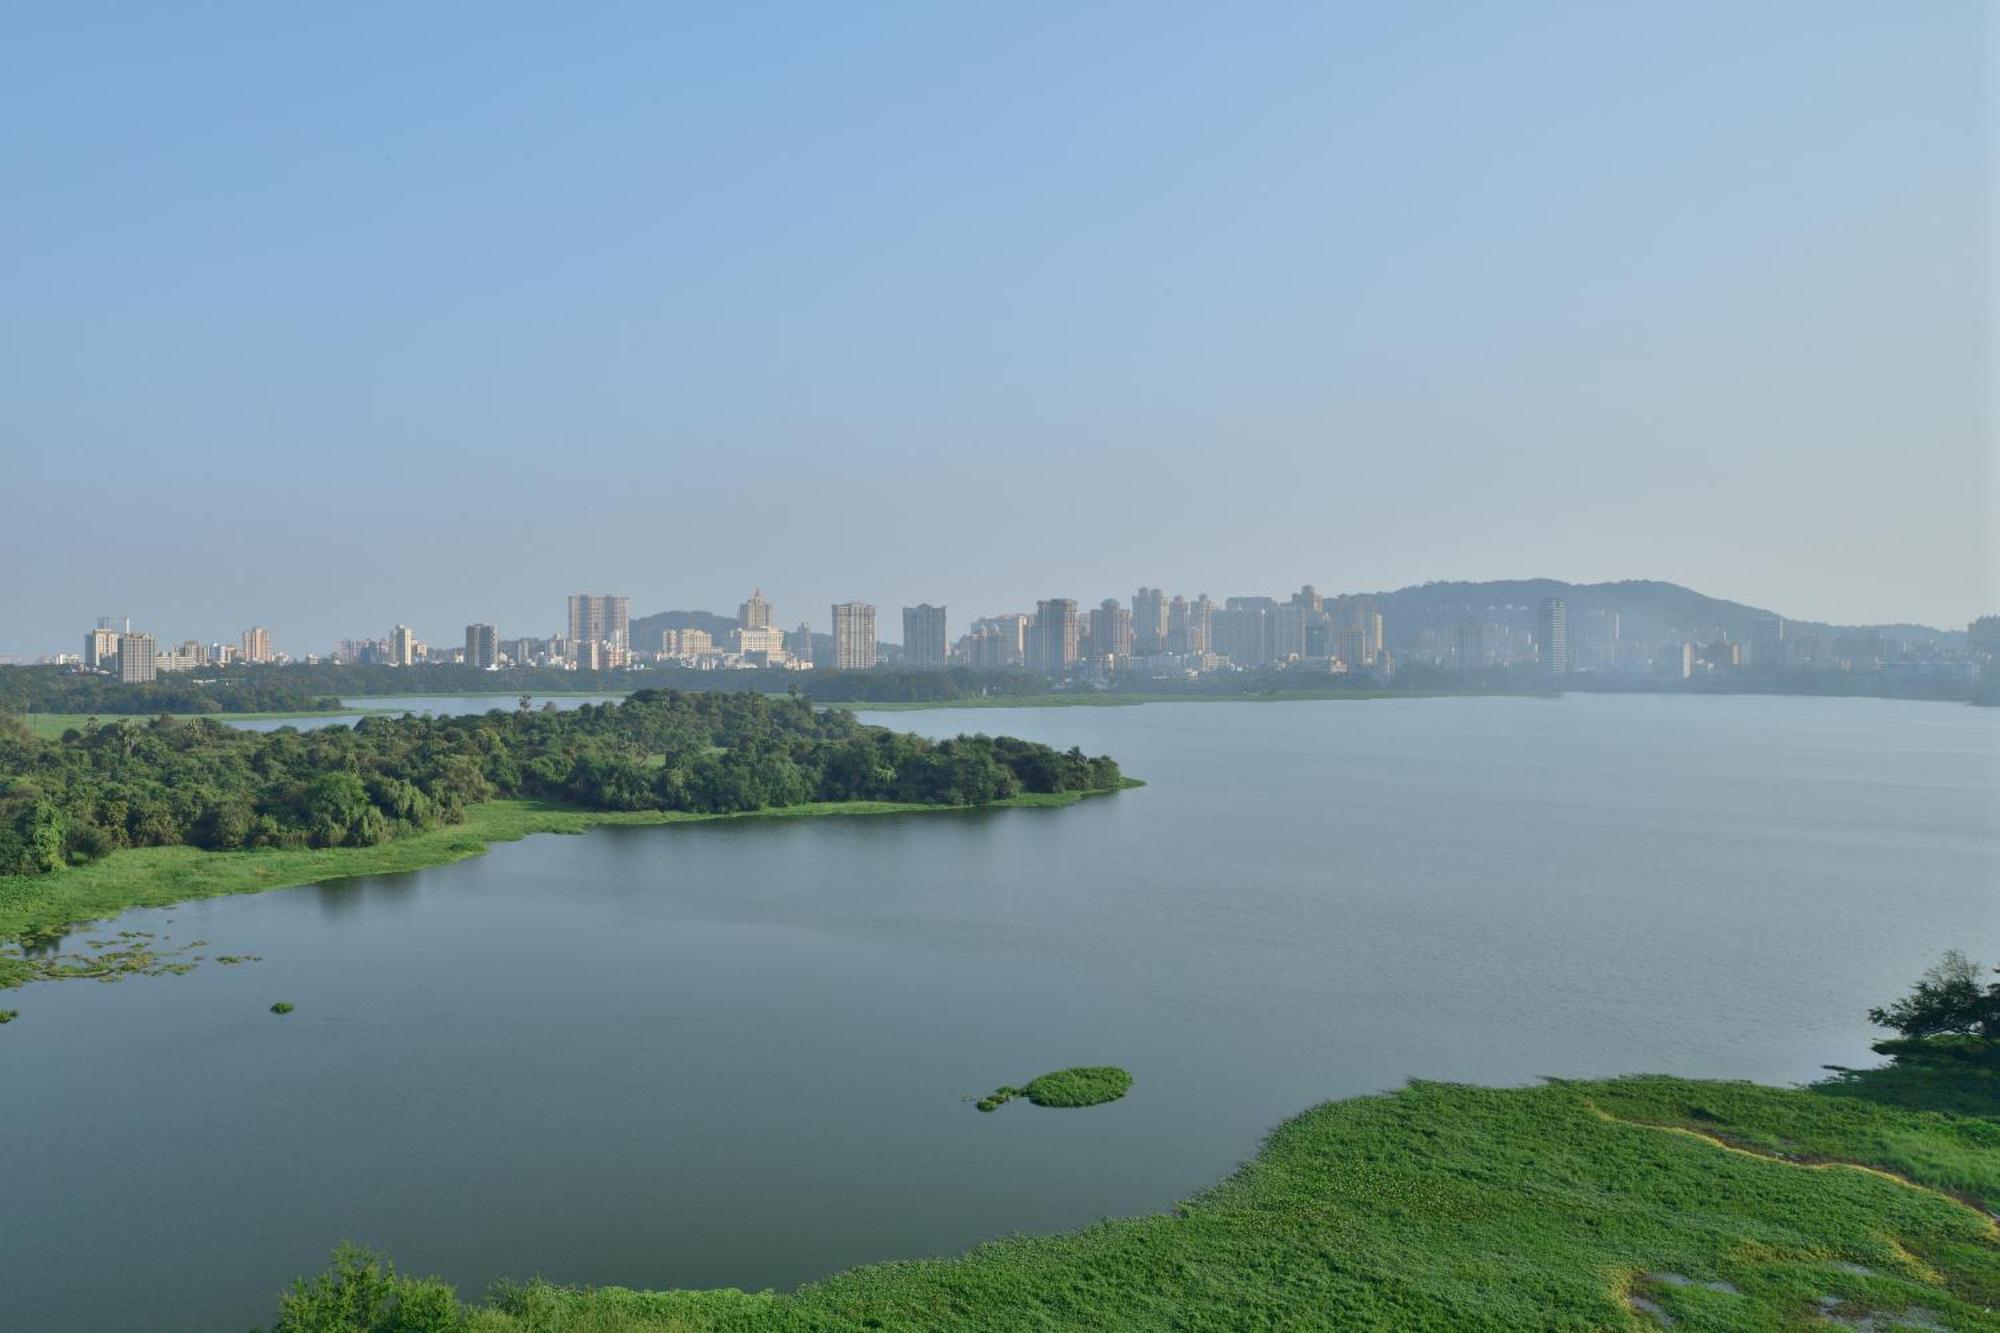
[{"xmin": 278, "ymin": 1077, "xmax": 2000, "ymax": 1333}]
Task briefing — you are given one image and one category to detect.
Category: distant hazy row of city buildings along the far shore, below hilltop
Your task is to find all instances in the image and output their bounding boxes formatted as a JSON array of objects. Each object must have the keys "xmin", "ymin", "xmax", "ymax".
[{"xmin": 27, "ymin": 584, "xmax": 2000, "ymax": 685}]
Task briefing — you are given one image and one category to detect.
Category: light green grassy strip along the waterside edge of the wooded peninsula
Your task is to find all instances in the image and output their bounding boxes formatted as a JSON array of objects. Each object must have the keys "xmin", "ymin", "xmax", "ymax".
[{"xmin": 0, "ymin": 781, "xmax": 1140, "ymax": 960}]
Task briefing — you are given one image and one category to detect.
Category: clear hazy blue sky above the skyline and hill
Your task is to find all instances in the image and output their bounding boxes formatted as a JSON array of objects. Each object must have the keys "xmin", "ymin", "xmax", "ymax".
[{"xmin": 0, "ymin": 0, "xmax": 2000, "ymax": 652}]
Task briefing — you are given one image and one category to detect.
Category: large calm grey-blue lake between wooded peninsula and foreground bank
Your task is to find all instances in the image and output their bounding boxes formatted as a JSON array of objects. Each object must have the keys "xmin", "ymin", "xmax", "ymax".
[{"xmin": 0, "ymin": 695, "xmax": 2000, "ymax": 1333}]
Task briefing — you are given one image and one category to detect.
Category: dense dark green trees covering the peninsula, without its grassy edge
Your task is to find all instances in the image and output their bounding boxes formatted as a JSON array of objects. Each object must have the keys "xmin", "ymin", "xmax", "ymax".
[{"xmin": 0, "ymin": 691, "xmax": 1124, "ymax": 875}]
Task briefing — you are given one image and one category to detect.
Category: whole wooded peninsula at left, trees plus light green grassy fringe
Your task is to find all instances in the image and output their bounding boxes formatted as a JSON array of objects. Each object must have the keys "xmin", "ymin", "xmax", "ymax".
[{"xmin": 0, "ymin": 691, "xmax": 1134, "ymax": 985}]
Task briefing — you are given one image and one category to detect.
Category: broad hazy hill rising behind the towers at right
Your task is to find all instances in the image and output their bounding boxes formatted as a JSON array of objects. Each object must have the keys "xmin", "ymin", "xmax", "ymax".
[{"xmin": 1370, "ymin": 578, "xmax": 1964, "ymax": 648}]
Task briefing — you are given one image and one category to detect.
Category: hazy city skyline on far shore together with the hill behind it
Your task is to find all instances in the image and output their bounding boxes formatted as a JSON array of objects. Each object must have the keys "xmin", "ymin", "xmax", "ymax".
[{"xmin": 39, "ymin": 580, "xmax": 2000, "ymax": 681}]
